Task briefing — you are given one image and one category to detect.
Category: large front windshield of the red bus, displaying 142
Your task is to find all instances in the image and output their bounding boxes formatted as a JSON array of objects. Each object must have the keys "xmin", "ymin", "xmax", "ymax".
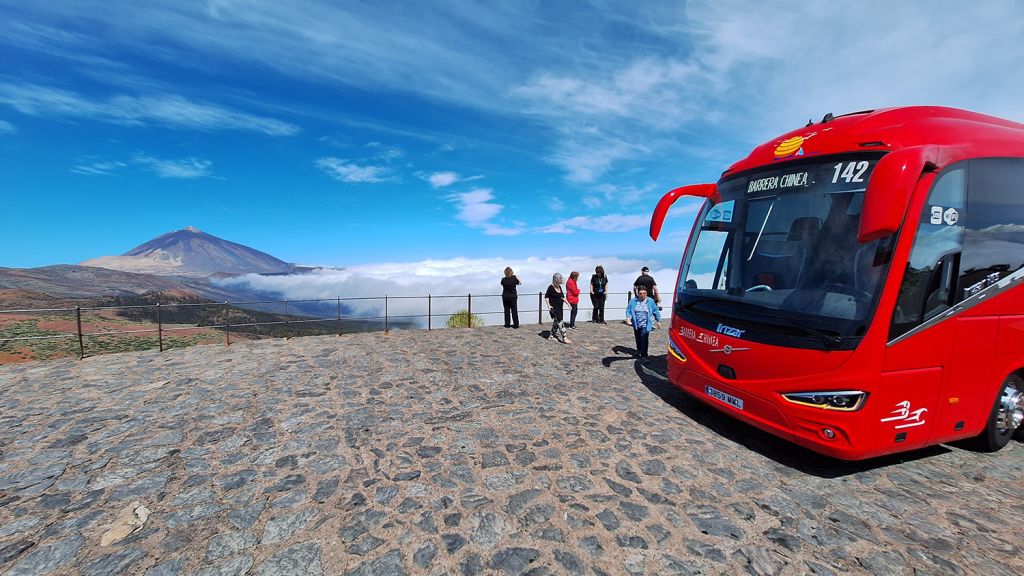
[{"xmin": 675, "ymin": 154, "xmax": 893, "ymax": 348}]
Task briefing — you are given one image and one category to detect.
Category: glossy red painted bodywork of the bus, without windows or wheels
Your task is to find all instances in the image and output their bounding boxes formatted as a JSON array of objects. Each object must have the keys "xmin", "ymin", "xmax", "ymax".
[{"xmin": 652, "ymin": 107, "xmax": 1024, "ymax": 460}]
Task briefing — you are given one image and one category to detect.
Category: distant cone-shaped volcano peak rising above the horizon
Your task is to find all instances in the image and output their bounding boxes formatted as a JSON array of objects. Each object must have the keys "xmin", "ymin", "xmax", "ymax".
[{"xmin": 81, "ymin": 227, "xmax": 295, "ymax": 277}]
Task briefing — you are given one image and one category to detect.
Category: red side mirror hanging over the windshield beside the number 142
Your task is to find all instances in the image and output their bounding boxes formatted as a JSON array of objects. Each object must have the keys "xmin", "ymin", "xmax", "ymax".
[{"xmin": 857, "ymin": 146, "xmax": 938, "ymax": 244}]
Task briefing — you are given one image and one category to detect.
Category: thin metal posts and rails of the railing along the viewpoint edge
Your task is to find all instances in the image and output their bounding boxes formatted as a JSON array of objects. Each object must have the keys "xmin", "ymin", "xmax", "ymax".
[{"xmin": 0, "ymin": 292, "xmax": 632, "ymax": 360}]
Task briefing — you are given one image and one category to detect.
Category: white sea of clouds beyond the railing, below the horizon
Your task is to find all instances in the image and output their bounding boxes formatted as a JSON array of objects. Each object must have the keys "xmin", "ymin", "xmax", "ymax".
[{"xmin": 219, "ymin": 256, "xmax": 678, "ymax": 327}]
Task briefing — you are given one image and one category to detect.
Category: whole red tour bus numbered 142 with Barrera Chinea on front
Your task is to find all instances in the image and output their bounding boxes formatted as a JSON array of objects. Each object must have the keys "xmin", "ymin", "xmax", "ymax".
[{"xmin": 650, "ymin": 107, "xmax": 1024, "ymax": 460}]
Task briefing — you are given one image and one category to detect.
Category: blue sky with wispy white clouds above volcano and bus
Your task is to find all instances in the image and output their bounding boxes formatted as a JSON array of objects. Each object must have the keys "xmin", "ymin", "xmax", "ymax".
[{"xmin": 0, "ymin": 0, "xmax": 1024, "ymax": 269}]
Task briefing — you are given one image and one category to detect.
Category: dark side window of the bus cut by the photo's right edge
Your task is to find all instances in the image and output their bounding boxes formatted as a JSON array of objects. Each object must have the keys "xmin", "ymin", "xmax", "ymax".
[{"xmin": 956, "ymin": 158, "xmax": 1024, "ymax": 301}]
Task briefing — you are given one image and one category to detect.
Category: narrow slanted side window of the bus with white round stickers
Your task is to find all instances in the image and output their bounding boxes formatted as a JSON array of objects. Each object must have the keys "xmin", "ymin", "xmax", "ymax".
[{"xmin": 889, "ymin": 163, "xmax": 967, "ymax": 339}]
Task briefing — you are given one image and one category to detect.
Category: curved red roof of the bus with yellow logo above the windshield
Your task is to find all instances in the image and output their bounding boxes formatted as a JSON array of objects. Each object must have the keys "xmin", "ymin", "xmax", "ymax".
[{"xmin": 722, "ymin": 106, "xmax": 1024, "ymax": 176}]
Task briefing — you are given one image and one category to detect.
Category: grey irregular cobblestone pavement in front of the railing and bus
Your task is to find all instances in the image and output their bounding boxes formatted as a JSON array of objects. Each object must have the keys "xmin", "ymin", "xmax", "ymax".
[{"xmin": 0, "ymin": 324, "xmax": 1024, "ymax": 576}]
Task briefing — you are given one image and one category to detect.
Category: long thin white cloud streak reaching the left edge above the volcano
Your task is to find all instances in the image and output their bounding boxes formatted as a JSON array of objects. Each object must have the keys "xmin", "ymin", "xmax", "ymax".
[{"xmin": 0, "ymin": 83, "xmax": 299, "ymax": 136}]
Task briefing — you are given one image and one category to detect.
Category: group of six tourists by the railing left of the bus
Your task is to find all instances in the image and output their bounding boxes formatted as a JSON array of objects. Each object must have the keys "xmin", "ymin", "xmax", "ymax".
[{"xmin": 501, "ymin": 265, "xmax": 662, "ymax": 358}]
